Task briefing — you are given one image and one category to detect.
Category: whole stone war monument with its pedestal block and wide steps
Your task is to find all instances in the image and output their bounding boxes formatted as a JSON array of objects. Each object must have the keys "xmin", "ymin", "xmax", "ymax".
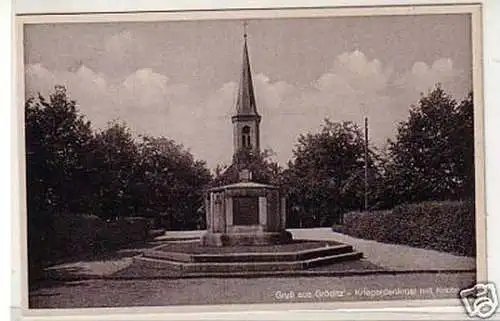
[{"xmin": 134, "ymin": 173, "xmax": 363, "ymax": 277}]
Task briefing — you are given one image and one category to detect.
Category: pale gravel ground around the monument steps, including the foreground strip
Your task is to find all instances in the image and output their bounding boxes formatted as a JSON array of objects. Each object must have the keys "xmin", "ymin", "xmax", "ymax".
[{"xmin": 29, "ymin": 228, "xmax": 475, "ymax": 309}]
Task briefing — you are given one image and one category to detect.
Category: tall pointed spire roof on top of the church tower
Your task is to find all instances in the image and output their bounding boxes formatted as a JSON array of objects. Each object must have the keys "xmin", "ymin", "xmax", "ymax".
[{"xmin": 236, "ymin": 33, "xmax": 258, "ymax": 116}]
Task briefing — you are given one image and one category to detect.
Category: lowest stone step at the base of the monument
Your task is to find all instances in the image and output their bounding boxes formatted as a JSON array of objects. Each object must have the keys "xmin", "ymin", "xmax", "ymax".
[{"xmin": 135, "ymin": 252, "xmax": 363, "ymax": 273}]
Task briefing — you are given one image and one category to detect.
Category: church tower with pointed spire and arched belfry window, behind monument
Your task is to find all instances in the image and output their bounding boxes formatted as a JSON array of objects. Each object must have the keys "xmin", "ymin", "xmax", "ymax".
[{"xmin": 232, "ymin": 30, "xmax": 261, "ymax": 153}]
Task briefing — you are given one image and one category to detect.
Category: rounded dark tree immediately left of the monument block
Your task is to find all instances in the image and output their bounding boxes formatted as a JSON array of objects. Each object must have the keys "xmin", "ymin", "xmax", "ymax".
[{"xmin": 138, "ymin": 137, "xmax": 212, "ymax": 229}]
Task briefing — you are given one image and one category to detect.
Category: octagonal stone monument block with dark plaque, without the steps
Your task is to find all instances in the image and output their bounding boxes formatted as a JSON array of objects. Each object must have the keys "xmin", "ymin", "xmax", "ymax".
[{"xmin": 201, "ymin": 182, "xmax": 292, "ymax": 246}]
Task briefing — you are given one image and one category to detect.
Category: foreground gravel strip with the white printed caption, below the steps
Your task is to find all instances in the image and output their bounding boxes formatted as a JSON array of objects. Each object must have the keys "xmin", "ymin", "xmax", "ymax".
[{"xmin": 29, "ymin": 273, "xmax": 475, "ymax": 309}]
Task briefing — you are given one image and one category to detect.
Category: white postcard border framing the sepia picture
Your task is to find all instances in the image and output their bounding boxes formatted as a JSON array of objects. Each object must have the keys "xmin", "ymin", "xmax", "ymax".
[{"xmin": 12, "ymin": 1, "xmax": 491, "ymax": 320}]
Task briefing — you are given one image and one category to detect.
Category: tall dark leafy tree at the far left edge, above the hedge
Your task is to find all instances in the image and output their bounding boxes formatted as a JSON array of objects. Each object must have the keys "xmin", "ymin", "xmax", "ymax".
[{"xmin": 26, "ymin": 86, "xmax": 93, "ymax": 213}]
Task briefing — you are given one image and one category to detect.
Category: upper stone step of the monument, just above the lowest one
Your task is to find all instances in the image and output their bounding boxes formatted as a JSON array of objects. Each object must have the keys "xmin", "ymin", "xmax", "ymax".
[{"xmin": 144, "ymin": 244, "xmax": 353, "ymax": 263}]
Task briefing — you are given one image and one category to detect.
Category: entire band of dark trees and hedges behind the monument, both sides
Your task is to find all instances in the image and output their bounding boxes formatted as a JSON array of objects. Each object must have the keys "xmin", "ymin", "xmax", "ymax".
[{"xmin": 25, "ymin": 80, "xmax": 475, "ymax": 278}]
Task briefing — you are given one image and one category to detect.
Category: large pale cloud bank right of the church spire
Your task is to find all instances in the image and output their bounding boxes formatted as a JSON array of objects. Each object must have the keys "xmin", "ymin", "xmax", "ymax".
[{"xmin": 256, "ymin": 51, "xmax": 469, "ymax": 163}]
